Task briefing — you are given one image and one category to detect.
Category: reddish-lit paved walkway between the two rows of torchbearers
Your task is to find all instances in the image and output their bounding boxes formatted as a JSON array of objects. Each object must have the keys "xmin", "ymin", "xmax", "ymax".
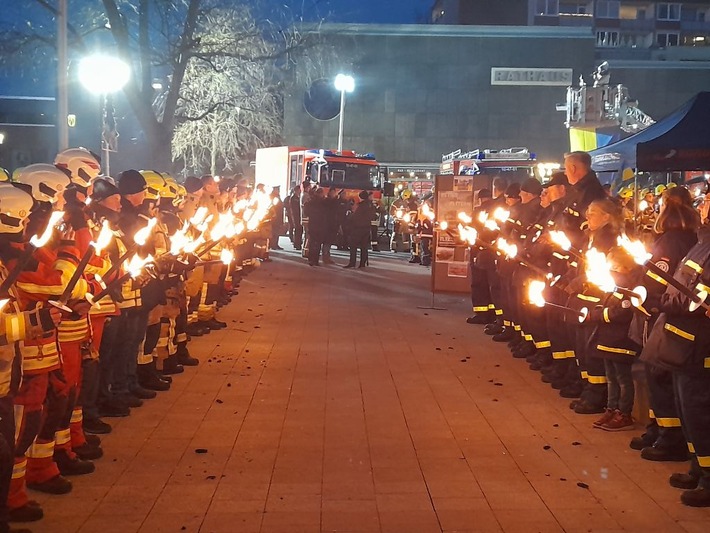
[{"xmin": 31, "ymin": 246, "xmax": 710, "ymax": 533}]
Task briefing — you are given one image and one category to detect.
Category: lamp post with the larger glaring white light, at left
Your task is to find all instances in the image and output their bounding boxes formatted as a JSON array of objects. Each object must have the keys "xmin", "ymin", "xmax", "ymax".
[{"xmin": 79, "ymin": 54, "xmax": 131, "ymax": 176}]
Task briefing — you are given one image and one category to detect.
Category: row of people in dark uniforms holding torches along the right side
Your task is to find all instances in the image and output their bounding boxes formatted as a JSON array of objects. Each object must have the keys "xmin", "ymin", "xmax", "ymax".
[{"xmin": 459, "ymin": 152, "xmax": 710, "ymax": 506}]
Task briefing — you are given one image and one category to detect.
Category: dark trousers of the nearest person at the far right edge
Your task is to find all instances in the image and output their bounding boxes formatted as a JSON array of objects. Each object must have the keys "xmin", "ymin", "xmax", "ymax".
[{"xmin": 673, "ymin": 369, "xmax": 710, "ymax": 490}]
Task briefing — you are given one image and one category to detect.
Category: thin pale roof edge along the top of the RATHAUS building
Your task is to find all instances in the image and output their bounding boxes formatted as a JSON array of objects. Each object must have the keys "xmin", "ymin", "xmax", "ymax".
[{"xmin": 301, "ymin": 23, "xmax": 594, "ymax": 39}]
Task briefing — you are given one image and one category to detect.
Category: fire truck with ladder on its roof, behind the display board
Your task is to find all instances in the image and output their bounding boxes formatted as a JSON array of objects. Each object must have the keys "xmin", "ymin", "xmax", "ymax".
[{"xmin": 439, "ymin": 147, "xmax": 538, "ymax": 189}]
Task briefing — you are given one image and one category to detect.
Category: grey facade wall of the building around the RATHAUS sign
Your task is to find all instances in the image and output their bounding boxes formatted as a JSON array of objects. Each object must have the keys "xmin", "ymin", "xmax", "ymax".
[{"xmin": 284, "ymin": 25, "xmax": 594, "ymax": 162}]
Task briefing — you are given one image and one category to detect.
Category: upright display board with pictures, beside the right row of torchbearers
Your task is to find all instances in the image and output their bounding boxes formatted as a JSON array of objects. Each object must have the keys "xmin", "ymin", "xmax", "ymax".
[{"xmin": 431, "ymin": 176, "xmax": 491, "ymax": 293}]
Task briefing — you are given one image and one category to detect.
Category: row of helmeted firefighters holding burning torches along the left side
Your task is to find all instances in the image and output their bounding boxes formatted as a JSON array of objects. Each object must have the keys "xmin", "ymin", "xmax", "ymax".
[{"xmin": 0, "ymin": 148, "xmax": 277, "ymax": 533}]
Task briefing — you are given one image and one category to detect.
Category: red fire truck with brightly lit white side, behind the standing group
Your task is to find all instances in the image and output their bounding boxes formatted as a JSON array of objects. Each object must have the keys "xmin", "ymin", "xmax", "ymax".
[{"xmin": 256, "ymin": 146, "xmax": 382, "ymax": 199}]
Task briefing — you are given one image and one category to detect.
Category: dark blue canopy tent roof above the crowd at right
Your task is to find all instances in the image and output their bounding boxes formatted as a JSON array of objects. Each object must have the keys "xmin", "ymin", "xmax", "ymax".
[{"xmin": 590, "ymin": 92, "xmax": 710, "ymax": 172}]
